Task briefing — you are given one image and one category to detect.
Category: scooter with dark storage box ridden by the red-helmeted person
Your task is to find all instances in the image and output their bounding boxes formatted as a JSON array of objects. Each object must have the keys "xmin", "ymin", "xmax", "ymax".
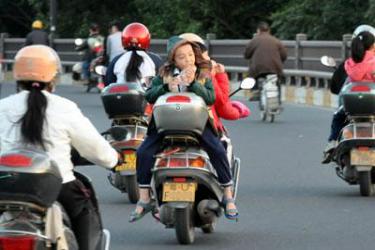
[{"xmin": 102, "ymin": 82, "xmax": 148, "ymax": 203}]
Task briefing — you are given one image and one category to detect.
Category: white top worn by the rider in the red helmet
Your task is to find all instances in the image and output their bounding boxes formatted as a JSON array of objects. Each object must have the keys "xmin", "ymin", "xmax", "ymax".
[{"xmin": 113, "ymin": 50, "xmax": 156, "ymax": 83}]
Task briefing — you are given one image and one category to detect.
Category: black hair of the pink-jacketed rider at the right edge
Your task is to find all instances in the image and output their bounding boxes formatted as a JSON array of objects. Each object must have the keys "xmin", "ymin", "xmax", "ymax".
[{"xmin": 351, "ymin": 31, "xmax": 375, "ymax": 63}]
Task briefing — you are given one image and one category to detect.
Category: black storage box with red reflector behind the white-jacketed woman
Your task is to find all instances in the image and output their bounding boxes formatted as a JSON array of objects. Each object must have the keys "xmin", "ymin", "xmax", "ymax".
[{"xmin": 0, "ymin": 150, "xmax": 62, "ymax": 207}]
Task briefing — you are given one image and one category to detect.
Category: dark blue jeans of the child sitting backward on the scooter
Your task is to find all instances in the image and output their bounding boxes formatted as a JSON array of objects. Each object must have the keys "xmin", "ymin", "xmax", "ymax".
[{"xmin": 136, "ymin": 126, "xmax": 232, "ymax": 188}]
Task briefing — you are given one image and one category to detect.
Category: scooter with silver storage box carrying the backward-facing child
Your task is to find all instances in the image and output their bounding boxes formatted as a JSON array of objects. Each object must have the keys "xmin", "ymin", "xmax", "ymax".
[{"xmin": 151, "ymin": 78, "xmax": 255, "ymax": 244}]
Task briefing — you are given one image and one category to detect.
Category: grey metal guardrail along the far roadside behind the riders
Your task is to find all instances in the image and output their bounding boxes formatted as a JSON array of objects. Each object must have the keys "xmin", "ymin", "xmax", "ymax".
[{"xmin": 0, "ymin": 33, "xmax": 338, "ymax": 88}]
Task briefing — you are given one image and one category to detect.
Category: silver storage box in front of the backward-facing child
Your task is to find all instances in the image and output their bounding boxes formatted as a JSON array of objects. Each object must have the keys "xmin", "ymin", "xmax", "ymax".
[{"xmin": 153, "ymin": 93, "xmax": 209, "ymax": 134}]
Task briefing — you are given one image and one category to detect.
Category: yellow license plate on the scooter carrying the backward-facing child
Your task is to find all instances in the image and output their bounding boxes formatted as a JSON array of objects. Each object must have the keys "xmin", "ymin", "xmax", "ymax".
[{"xmin": 163, "ymin": 182, "xmax": 197, "ymax": 202}]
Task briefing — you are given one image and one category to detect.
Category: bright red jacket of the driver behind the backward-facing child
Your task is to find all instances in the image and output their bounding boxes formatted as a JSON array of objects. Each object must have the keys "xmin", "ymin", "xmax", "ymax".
[{"xmin": 212, "ymin": 73, "xmax": 240, "ymax": 132}]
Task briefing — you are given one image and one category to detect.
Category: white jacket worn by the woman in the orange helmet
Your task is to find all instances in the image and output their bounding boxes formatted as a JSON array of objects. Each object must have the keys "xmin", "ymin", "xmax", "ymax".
[{"xmin": 0, "ymin": 91, "xmax": 117, "ymax": 183}]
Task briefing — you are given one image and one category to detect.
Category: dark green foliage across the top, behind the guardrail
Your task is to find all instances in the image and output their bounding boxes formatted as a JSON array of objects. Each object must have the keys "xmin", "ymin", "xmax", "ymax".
[{"xmin": 0, "ymin": 0, "xmax": 375, "ymax": 40}]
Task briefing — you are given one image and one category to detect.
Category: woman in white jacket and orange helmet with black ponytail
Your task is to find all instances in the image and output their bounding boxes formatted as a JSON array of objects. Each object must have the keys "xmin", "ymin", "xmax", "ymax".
[{"xmin": 0, "ymin": 45, "xmax": 118, "ymax": 250}]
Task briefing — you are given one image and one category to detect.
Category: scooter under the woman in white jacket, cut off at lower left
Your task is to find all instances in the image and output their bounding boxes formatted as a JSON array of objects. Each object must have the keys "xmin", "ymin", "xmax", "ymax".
[{"xmin": 0, "ymin": 149, "xmax": 110, "ymax": 250}]
